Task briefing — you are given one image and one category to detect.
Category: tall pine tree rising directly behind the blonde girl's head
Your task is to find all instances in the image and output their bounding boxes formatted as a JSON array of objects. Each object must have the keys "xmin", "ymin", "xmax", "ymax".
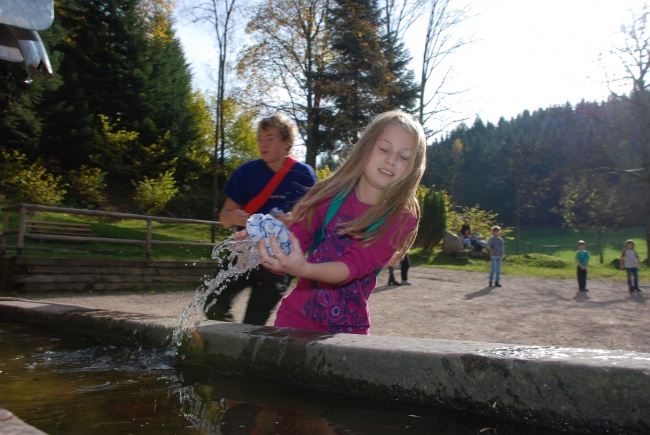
[{"xmin": 328, "ymin": 0, "xmax": 418, "ymax": 146}]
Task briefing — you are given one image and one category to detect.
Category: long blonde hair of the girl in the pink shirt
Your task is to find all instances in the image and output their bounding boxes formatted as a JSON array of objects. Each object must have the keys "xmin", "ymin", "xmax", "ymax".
[{"xmin": 293, "ymin": 110, "xmax": 426, "ymax": 264}]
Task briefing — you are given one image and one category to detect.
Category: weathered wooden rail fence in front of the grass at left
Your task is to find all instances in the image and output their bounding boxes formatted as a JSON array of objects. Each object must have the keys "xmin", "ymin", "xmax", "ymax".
[{"xmin": 0, "ymin": 204, "xmax": 221, "ymax": 260}]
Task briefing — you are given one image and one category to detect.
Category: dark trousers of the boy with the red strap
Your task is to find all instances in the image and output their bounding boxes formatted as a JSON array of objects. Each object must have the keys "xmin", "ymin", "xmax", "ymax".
[{"xmin": 204, "ymin": 266, "xmax": 291, "ymax": 325}]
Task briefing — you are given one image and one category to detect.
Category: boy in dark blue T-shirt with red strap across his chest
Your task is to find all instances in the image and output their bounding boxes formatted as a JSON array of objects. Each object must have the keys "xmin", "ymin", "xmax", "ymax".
[{"xmin": 204, "ymin": 114, "xmax": 317, "ymax": 325}]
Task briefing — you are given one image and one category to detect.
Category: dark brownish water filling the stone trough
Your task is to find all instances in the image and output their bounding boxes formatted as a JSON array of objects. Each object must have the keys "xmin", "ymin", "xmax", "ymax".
[{"xmin": 0, "ymin": 322, "xmax": 559, "ymax": 435}]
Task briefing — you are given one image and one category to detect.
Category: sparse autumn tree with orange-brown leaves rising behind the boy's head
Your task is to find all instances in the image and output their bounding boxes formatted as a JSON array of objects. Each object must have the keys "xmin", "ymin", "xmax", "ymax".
[{"xmin": 238, "ymin": 0, "xmax": 333, "ymax": 167}]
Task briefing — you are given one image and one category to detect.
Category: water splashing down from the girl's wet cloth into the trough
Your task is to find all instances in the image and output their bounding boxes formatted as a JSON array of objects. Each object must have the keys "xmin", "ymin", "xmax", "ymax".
[{"xmin": 172, "ymin": 236, "xmax": 262, "ymax": 347}]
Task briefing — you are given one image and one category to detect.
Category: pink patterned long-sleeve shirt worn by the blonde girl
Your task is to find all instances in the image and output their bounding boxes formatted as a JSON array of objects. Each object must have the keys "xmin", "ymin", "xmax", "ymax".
[{"xmin": 275, "ymin": 189, "xmax": 416, "ymax": 334}]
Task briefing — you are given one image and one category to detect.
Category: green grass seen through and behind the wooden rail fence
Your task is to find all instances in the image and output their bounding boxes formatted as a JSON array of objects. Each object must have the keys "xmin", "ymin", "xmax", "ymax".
[{"xmin": 0, "ymin": 212, "xmax": 230, "ymax": 261}]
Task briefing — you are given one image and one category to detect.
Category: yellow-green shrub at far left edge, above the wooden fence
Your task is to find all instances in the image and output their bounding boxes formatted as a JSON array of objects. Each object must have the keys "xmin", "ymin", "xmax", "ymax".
[{"xmin": 0, "ymin": 150, "xmax": 67, "ymax": 205}]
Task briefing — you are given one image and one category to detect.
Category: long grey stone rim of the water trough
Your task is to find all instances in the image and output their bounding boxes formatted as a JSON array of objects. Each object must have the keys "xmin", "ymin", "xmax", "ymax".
[{"xmin": 0, "ymin": 298, "xmax": 650, "ymax": 434}]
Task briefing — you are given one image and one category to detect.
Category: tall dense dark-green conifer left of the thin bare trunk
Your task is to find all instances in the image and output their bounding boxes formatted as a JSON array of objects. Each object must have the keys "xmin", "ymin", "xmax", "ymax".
[{"xmin": 35, "ymin": 0, "xmax": 198, "ymax": 193}]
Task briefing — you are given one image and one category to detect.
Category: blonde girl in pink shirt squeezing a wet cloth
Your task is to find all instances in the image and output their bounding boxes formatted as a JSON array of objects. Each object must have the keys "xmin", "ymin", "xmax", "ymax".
[{"xmin": 236, "ymin": 111, "xmax": 426, "ymax": 334}]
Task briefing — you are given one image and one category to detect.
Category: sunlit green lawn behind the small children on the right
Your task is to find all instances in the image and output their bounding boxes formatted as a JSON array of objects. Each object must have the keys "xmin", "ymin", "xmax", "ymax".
[{"xmin": 409, "ymin": 228, "xmax": 650, "ymax": 281}]
